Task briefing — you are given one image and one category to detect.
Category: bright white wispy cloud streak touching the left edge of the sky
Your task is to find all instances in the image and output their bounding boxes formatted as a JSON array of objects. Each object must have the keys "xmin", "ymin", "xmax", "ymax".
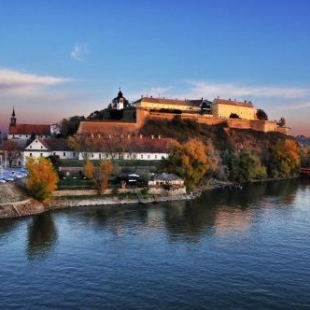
[{"xmin": 0, "ymin": 68, "xmax": 71, "ymax": 90}]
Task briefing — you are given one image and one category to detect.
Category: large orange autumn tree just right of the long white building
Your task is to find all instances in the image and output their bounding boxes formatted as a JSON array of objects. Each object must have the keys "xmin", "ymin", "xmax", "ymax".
[{"xmin": 159, "ymin": 138, "xmax": 217, "ymax": 190}]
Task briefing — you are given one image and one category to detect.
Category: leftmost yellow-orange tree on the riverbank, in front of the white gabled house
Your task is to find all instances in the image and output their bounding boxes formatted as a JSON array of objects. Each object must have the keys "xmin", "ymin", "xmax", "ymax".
[{"xmin": 26, "ymin": 157, "xmax": 59, "ymax": 203}]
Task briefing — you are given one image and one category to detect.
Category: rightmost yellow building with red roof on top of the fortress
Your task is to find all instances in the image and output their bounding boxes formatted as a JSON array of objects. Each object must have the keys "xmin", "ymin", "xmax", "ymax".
[{"xmin": 212, "ymin": 98, "xmax": 257, "ymax": 120}]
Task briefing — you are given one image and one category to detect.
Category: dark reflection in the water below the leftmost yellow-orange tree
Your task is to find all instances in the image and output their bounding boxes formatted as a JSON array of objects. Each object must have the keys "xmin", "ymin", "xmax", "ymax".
[{"xmin": 27, "ymin": 212, "xmax": 57, "ymax": 260}]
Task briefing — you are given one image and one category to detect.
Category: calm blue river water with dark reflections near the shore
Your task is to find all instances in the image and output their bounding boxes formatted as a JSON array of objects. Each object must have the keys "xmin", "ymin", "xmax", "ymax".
[{"xmin": 0, "ymin": 180, "xmax": 310, "ymax": 309}]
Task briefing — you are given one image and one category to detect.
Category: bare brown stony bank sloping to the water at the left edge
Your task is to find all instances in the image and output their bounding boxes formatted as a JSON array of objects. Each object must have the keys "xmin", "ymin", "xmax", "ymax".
[{"xmin": 0, "ymin": 183, "xmax": 45, "ymax": 219}]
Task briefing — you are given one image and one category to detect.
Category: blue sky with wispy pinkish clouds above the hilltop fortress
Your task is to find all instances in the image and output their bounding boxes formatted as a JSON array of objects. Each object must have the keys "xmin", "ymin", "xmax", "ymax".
[{"xmin": 0, "ymin": 0, "xmax": 310, "ymax": 136}]
